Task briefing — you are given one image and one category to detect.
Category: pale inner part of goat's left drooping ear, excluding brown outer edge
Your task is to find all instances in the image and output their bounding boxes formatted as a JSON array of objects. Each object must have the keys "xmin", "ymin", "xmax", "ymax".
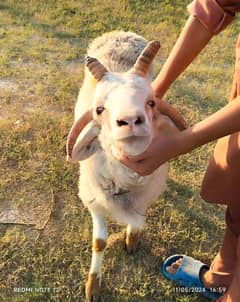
[{"xmin": 71, "ymin": 121, "xmax": 100, "ymax": 161}]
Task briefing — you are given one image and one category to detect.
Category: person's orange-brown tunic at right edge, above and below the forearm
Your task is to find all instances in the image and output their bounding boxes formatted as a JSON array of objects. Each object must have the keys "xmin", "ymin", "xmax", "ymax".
[{"xmin": 201, "ymin": 34, "xmax": 240, "ymax": 204}]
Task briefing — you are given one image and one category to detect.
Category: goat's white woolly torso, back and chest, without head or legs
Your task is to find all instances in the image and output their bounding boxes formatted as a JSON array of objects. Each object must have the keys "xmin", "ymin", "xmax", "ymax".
[{"xmin": 75, "ymin": 32, "xmax": 168, "ymax": 228}]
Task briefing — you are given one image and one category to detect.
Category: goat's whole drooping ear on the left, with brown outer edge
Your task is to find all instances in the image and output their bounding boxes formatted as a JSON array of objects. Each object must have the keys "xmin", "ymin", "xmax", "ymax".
[{"xmin": 66, "ymin": 111, "xmax": 100, "ymax": 162}]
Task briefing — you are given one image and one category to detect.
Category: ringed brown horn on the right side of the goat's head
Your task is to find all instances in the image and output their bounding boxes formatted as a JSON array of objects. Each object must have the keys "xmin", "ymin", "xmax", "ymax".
[{"xmin": 130, "ymin": 40, "xmax": 160, "ymax": 77}]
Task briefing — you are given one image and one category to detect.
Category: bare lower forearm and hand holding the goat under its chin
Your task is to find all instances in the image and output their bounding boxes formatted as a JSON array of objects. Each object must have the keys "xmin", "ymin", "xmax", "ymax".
[{"xmin": 120, "ymin": 97, "xmax": 240, "ymax": 176}]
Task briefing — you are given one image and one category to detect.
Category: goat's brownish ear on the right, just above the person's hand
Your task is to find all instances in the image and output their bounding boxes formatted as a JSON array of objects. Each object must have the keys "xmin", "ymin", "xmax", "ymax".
[{"xmin": 156, "ymin": 99, "xmax": 188, "ymax": 131}]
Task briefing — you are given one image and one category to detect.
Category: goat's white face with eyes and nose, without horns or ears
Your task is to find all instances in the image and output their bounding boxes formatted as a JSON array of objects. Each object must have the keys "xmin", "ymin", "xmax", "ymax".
[{"xmin": 93, "ymin": 72, "xmax": 155, "ymax": 157}]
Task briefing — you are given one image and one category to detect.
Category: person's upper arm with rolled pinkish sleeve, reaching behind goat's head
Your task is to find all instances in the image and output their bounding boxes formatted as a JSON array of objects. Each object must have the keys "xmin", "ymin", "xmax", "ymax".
[{"xmin": 152, "ymin": 0, "xmax": 240, "ymax": 98}]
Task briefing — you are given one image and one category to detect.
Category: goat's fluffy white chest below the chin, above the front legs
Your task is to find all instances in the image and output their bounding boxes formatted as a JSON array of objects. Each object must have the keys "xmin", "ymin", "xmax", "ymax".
[{"xmin": 79, "ymin": 147, "xmax": 168, "ymax": 228}]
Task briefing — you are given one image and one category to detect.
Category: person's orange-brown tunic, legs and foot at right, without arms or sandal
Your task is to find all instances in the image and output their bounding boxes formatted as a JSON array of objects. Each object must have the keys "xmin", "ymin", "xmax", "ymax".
[{"xmin": 167, "ymin": 35, "xmax": 240, "ymax": 302}]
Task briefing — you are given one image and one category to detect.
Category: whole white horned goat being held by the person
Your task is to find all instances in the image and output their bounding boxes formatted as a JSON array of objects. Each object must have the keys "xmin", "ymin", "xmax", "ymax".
[{"xmin": 67, "ymin": 32, "xmax": 187, "ymax": 301}]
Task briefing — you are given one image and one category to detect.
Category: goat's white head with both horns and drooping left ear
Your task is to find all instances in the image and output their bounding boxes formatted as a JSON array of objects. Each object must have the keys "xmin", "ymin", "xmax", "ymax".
[{"xmin": 67, "ymin": 41, "xmax": 187, "ymax": 161}]
